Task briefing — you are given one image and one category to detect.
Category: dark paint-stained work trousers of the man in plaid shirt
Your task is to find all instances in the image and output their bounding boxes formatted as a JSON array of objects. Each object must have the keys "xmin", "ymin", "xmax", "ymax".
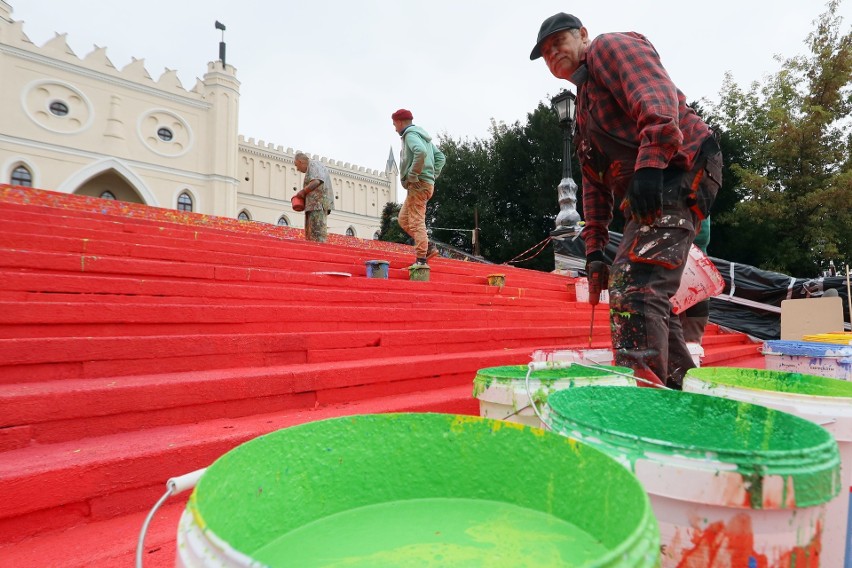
[{"xmin": 609, "ymin": 138, "xmax": 722, "ymax": 388}]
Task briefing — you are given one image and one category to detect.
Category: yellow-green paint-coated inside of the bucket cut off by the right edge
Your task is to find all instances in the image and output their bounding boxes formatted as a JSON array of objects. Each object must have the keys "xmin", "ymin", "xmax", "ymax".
[{"xmin": 686, "ymin": 367, "xmax": 852, "ymax": 398}]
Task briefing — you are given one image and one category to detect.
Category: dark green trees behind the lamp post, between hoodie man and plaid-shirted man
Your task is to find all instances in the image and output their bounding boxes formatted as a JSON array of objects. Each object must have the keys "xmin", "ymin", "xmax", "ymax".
[{"xmin": 427, "ymin": 103, "xmax": 564, "ymax": 270}]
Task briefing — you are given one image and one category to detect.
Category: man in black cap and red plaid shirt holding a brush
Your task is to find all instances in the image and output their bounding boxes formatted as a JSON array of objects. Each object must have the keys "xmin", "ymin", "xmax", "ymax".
[{"xmin": 530, "ymin": 13, "xmax": 722, "ymax": 388}]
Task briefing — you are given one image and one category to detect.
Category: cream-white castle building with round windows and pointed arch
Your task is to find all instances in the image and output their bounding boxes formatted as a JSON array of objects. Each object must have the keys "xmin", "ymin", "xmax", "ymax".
[{"xmin": 0, "ymin": 0, "xmax": 398, "ymax": 239}]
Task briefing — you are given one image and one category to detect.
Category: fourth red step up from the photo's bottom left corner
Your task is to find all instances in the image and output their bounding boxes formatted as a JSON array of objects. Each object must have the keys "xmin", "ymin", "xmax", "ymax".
[{"xmin": 0, "ymin": 325, "xmax": 588, "ymax": 384}]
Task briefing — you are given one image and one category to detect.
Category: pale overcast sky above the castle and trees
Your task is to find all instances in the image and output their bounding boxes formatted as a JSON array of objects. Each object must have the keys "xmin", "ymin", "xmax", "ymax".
[{"xmin": 7, "ymin": 0, "xmax": 852, "ymax": 180}]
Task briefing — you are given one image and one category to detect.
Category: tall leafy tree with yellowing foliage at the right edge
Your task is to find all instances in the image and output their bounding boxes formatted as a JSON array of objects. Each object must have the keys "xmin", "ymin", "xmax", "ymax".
[{"xmin": 711, "ymin": 0, "xmax": 852, "ymax": 276}]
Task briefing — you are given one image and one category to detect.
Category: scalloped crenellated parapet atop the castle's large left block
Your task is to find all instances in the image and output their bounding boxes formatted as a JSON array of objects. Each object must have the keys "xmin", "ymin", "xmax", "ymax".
[{"xmin": 0, "ymin": 10, "xmax": 215, "ymax": 101}]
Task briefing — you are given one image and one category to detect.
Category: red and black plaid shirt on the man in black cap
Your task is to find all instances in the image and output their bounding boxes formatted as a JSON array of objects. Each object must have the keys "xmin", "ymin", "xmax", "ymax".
[{"xmin": 571, "ymin": 32, "xmax": 711, "ymax": 252}]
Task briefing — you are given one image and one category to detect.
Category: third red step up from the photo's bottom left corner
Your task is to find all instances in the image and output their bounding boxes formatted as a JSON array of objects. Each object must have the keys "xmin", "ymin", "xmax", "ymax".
[{"xmin": 0, "ymin": 344, "xmax": 553, "ymax": 449}]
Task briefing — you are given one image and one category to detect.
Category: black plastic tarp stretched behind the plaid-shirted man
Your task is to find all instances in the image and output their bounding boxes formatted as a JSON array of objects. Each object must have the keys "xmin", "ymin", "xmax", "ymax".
[{"xmin": 554, "ymin": 232, "xmax": 850, "ymax": 339}]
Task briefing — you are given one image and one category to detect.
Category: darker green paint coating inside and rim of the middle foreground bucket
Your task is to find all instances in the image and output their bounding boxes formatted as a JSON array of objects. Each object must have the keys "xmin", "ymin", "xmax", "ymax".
[{"xmin": 545, "ymin": 386, "xmax": 840, "ymax": 508}]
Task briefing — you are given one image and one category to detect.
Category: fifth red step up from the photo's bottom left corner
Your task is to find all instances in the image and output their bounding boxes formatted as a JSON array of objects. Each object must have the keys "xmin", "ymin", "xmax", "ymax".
[{"xmin": 0, "ymin": 295, "xmax": 580, "ymax": 339}]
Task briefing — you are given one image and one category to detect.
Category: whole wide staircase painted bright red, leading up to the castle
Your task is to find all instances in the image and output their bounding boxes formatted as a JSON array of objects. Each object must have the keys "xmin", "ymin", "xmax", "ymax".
[{"xmin": 0, "ymin": 186, "xmax": 762, "ymax": 566}]
